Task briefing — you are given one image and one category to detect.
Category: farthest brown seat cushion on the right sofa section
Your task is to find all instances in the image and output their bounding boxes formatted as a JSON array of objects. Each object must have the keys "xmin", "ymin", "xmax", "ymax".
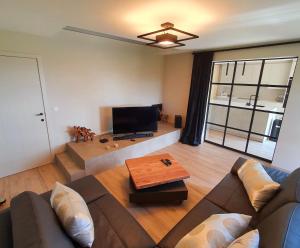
[{"xmin": 205, "ymin": 174, "xmax": 256, "ymax": 216}]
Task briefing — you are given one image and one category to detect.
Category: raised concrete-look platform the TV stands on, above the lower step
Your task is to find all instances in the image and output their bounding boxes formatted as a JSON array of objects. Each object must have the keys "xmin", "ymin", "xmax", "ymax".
[{"xmin": 67, "ymin": 123, "xmax": 181, "ymax": 175}]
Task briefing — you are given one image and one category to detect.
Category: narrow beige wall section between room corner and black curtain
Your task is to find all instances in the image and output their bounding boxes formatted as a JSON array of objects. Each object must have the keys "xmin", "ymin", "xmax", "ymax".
[{"xmin": 163, "ymin": 53, "xmax": 193, "ymax": 123}]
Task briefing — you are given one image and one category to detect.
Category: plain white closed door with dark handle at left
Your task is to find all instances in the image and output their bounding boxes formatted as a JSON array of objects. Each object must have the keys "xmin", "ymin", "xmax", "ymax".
[{"xmin": 0, "ymin": 55, "xmax": 50, "ymax": 177}]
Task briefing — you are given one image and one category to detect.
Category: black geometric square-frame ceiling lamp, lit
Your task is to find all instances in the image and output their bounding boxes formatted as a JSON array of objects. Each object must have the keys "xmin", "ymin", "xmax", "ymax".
[{"xmin": 137, "ymin": 22, "xmax": 199, "ymax": 49}]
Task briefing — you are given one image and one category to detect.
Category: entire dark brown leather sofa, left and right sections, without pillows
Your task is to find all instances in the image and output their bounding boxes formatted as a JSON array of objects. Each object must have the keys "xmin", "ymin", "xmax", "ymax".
[{"xmin": 0, "ymin": 158, "xmax": 300, "ymax": 248}]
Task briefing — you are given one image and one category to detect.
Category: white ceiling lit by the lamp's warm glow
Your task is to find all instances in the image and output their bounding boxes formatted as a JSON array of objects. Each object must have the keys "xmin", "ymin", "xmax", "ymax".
[{"xmin": 0, "ymin": 0, "xmax": 300, "ymax": 50}]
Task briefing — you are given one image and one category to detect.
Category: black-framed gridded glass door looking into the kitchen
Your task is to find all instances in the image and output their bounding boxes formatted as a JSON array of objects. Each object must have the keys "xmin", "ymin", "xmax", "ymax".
[{"xmin": 205, "ymin": 57, "xmax": 297, "ymax": 161}]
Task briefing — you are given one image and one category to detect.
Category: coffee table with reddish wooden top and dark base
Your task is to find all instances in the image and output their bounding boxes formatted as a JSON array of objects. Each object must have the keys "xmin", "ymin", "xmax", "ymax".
[{"xmin": 125, "ymin": 153, "xmax": 190, "ymax": 204}]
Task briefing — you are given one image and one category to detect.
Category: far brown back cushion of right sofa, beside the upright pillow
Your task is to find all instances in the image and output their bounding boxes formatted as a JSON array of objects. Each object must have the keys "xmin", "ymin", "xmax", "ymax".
[{"xmin": 250, "ymin": 168, "xmax": 300, "ymax": 227}]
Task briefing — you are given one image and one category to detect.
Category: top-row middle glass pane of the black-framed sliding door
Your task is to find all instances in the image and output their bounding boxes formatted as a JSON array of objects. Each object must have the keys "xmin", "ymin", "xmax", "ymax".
[{"xmin": 234, "ymin": 60, "xmax": 262, "ymax": 84}]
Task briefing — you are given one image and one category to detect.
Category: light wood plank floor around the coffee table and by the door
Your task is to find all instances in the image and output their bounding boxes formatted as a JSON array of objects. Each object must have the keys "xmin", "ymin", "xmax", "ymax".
[{"xmin": 0, "ymin": 143, "xmax": 255, "ymax": 241}]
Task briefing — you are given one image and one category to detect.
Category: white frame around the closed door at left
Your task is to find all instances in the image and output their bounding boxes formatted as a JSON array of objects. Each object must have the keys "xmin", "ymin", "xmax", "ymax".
[{"xmin": 0, "ymin": 50, "xmax": 55, "ymax": 163}]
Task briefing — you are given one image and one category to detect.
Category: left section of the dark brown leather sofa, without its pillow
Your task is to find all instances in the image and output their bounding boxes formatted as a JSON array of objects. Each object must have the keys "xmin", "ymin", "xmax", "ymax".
[{"xmin": 0, "ymin": 176, "xmax": 155, "ymax": 248}]
